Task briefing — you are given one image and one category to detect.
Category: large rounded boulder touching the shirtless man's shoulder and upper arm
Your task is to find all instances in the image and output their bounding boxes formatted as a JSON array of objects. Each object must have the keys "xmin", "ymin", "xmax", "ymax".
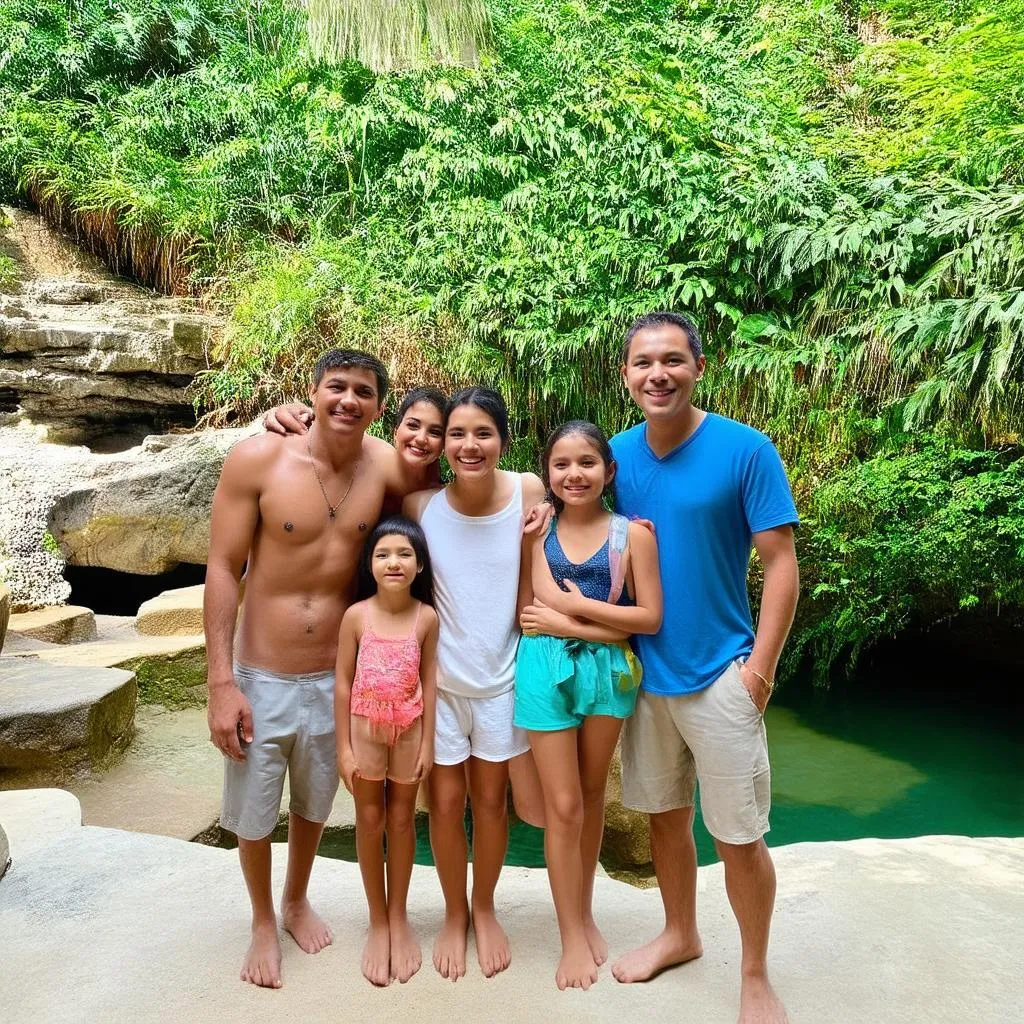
[{"xmin": 49, "ymin": 430, "xmax": 251, "ymax": 574}]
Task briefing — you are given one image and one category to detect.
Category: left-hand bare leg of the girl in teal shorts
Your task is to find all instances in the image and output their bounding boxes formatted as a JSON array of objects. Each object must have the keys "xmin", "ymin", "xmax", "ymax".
[{"xmin": 529, "ymin": 729, "xmax": 597, "ymax": 989}]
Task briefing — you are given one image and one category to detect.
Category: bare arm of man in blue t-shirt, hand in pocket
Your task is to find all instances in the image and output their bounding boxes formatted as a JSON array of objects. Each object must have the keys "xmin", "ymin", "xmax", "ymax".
[{"xmin": 740, "ymin": 526, "xmax": 800, "ymax": 711}]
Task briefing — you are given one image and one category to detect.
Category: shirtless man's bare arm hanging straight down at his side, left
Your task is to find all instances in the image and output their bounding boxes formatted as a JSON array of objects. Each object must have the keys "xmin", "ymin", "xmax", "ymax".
[{"xmin": 203, "ymin": 438, "xmax": 272, "ymax": 761}]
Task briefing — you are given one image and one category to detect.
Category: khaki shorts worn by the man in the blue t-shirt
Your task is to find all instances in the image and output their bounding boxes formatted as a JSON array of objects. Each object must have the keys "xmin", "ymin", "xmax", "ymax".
[{"xmin": 623, "ymin": 662, "xmax": 771, "ymax": 846}]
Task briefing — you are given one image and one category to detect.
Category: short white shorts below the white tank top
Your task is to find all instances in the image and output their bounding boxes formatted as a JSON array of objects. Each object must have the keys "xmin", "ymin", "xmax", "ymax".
[{"xmin": 434, "ymin": 690, "xmax": 529, "ymax": 765}]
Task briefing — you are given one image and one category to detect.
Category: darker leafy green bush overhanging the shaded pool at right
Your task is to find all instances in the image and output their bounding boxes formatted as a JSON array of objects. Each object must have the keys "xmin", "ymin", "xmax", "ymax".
[{"xmin": 790, "ymin": 438, "xmax": 1024, "ymax": 679}]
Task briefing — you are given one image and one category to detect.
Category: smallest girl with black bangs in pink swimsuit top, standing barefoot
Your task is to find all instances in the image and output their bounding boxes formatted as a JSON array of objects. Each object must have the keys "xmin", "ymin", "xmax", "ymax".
[{"xmin": 334, "ymin": 516, "xmax": 437, "ymax": 985}]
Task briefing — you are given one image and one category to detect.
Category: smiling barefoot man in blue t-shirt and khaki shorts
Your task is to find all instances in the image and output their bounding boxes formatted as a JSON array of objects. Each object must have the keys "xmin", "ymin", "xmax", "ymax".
[{"xmin": 611, "ymin": 312, "xmax": 800, "ymax": 1022}]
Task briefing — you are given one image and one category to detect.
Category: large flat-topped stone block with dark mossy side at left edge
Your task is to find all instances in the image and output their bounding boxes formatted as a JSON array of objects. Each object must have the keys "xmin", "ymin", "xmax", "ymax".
[{"xmin": 0, "ymin": 657, "xmax": 137, "ymax": 768}]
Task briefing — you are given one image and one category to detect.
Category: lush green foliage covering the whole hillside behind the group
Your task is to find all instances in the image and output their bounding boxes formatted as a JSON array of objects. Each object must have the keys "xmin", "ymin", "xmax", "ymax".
[{"xmin": 0, "ymin": 0, "xmax": 1024, "ymax": 679}]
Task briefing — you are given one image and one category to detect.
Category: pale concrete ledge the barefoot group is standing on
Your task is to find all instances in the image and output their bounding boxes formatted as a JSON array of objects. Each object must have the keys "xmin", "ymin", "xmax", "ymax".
[{"xmin": 0, "ymin": 827, "xmax": 1024, "ymax": 1024}]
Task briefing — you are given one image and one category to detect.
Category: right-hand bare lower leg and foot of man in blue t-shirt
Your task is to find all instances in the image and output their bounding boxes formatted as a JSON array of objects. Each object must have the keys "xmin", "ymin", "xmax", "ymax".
[{"xmin": 715, "ymin": 840, "xmax": 787, "ymax": 1024}]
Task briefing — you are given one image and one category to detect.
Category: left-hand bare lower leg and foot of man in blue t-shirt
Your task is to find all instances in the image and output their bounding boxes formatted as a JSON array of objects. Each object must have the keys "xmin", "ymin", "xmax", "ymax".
[{"xmin": 611, "ymin": 807, "xmax": 703, "ymax": 982}]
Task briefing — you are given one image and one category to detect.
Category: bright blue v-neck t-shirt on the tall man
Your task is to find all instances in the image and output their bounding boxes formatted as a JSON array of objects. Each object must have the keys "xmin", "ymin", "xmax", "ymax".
[{"xmin": 611, "ymin": 413, "xmax": 799, "ymax": 696}]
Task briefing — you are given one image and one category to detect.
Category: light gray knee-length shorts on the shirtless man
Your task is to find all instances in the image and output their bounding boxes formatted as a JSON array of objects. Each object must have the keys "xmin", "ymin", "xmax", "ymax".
[{"xmin": 220, "ymin": 665, "xmax": 338, "ymax": 840}]
